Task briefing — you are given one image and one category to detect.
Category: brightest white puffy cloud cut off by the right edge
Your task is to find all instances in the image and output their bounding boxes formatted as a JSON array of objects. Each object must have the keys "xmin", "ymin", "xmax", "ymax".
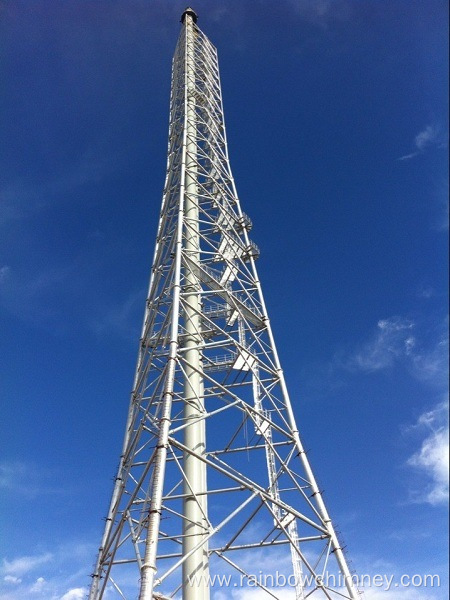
[{"xmin": 407, "ymin": 402, "xmax": 449, "ymax": 505}]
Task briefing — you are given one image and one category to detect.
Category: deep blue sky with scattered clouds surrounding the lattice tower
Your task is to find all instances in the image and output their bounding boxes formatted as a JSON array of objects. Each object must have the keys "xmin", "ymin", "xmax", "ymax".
[{"xmin": 0, "ymin": 0, "xmax": 448, "ymax": 600}]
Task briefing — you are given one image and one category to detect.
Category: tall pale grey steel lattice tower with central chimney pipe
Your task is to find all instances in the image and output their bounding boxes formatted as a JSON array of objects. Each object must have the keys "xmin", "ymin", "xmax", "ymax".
[{"xmin": 90, "ymin": 8, "xmax": 359, "ymax": 600}]
